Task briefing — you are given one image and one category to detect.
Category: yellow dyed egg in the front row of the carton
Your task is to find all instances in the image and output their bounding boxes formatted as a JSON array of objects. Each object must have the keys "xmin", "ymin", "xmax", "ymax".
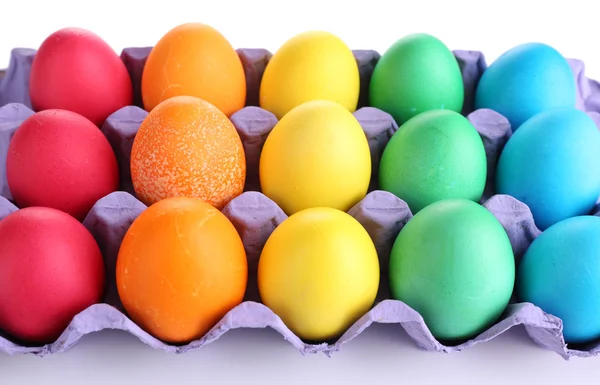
[{"xmin": 258, "ymin": 207, "xmax": 379, "ymax": 341}]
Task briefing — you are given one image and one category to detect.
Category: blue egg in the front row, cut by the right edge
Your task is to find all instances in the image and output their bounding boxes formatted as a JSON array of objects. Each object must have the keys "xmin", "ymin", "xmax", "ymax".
[{"xmin": 516, "ymin": 216, "xmax": 600, "ymax": 343}]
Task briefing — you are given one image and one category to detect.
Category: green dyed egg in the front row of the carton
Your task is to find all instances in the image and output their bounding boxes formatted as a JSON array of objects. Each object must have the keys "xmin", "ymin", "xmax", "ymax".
[{"xmin": 389, "ymin": 199, "xmax": 515, "ymax": 340}]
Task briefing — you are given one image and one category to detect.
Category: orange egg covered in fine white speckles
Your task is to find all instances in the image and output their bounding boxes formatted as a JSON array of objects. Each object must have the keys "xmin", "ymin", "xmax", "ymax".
[{"xmin": 131, "ymin": 96, "xmax": 246, "ymax": 209}]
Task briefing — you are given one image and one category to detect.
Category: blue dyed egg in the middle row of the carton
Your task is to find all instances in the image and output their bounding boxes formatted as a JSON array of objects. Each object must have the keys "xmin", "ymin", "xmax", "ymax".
[{"xmin": 496, "ymin": 108, "xmax": 600, "ymax": 230}]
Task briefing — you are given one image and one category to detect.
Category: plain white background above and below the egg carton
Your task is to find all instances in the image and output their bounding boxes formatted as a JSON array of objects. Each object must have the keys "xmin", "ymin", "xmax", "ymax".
[{"xmin": 0, "ymin": 0, "xmax": 600, "ymax": 385}]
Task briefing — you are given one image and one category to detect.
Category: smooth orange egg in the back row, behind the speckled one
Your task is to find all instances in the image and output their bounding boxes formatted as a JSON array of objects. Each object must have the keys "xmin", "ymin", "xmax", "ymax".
[{"xmin": 142, "ymin": 23, "xmax": 246, "ymax": 116}]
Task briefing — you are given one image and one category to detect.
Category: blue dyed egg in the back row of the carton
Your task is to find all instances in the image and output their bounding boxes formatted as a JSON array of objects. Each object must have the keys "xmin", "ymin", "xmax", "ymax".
[{"xmin": 475, "ymin": 43, "xmax": 577, "ymax": 131}]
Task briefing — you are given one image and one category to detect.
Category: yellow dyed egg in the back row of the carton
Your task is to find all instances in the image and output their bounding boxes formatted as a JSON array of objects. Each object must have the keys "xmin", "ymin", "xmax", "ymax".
[{"xmin": 259, "ymin": 31, "xmax": 360, "ymax": 119}]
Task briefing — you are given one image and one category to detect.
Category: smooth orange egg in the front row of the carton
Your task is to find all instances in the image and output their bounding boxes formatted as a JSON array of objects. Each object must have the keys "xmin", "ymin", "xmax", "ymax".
[{"xmin": 117, "ymin": 197, "xmax": 248, "ymax": 343}]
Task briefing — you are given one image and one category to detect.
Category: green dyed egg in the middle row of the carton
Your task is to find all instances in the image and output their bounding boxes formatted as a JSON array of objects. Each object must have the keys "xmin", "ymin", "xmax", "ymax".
[{"xmin": 379, "ymin": 110, "xmax": 487, "ymax": 214}]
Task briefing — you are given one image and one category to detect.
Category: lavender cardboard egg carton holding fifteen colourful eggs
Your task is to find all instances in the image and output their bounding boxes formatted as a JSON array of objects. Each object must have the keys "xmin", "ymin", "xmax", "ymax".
[{"xmin": 0, "ymin": 47, "xmax": 600, "ymax": 359}]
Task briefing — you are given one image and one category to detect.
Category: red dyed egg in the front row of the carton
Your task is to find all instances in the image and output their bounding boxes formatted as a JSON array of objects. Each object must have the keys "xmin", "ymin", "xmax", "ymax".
[{"xmin": 0, "ymin": 207, "xmax": 105, "ymax": 345}]
